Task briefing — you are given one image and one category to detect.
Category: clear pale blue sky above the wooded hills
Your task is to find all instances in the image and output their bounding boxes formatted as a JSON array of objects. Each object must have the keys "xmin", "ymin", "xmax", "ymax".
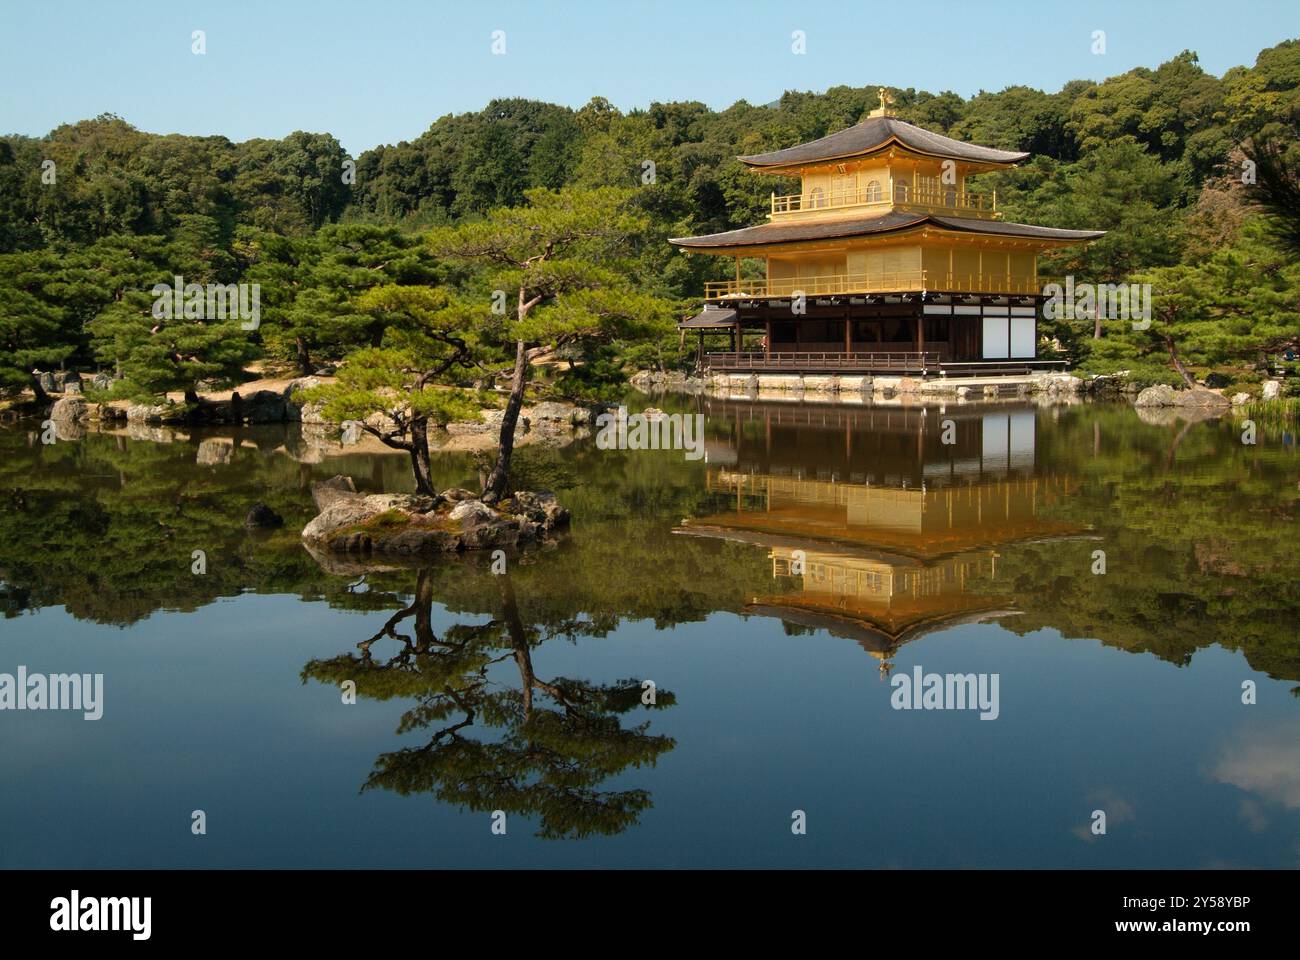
[{"xmin": 0, "ymin": 0, "xmax": 1300, "ymax": 153}]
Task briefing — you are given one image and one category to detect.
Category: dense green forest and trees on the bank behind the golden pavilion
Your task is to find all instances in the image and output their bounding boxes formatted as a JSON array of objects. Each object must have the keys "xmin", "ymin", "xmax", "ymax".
[{"xmin": 0, "ymin": 40, "xmax": 1300, "ymax": 395}]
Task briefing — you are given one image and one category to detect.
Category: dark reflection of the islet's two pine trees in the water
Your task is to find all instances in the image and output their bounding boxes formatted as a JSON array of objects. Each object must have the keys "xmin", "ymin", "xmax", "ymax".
[{"xmin": 303, "ymin": 570, "xmax": 675, "ymax": 838}]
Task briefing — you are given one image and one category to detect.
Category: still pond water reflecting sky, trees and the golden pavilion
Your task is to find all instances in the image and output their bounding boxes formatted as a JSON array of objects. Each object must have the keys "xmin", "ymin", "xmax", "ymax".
[{"xmin": 0, "ymin": 398, "xmax": 1300, "ymax": 868}]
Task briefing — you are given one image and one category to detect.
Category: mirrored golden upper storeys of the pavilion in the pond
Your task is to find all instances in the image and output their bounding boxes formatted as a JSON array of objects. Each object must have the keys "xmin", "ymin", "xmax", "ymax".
[{"xmin": 679, "ymin": 470, "xmax": 1078, "ymax": 660}]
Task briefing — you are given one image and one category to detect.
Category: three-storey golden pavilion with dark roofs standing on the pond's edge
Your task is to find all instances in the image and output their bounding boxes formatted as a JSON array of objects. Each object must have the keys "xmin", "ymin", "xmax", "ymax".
[{"xmin": 670, "ymin": 90, "xmax": 1104, "ymax": 376}]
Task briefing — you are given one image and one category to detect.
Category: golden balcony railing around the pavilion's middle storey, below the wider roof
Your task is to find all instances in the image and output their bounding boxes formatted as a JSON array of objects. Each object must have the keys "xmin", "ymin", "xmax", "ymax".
[{"xmin": 705, "ymin": 271, "xmax": 1050, "ymax": 300}]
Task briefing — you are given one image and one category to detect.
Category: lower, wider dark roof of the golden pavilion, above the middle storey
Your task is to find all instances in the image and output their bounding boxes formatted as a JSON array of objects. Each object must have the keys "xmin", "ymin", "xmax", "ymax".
[{"xmin": 668, "ymin": 211, "xmax": 1106, "ymax": 250}]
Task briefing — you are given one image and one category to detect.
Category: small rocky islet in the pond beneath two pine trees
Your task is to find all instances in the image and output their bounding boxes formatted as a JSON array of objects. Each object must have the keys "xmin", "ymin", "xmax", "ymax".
[{"xmin": 303, "ymin": 476, "xmax": 569, "ymax": 557}]
